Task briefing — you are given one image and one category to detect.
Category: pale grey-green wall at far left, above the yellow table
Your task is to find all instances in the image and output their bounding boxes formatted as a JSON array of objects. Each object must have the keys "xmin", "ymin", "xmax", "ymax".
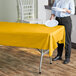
[{"xmin": 0, "ymin": 0, "xmax": 17, "ymax": 22}]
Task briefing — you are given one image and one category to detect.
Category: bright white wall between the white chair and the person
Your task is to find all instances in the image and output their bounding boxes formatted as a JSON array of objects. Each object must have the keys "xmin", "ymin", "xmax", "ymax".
[{"xmin": 38, "ymin": 0, "xmax": 51, "ymax": 23}]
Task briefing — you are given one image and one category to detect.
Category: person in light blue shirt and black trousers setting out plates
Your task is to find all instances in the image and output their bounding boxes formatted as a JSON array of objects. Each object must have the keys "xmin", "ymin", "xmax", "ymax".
[{"xmin": 50, "ymin": 0, "xmax": 75, "ymax": 64}]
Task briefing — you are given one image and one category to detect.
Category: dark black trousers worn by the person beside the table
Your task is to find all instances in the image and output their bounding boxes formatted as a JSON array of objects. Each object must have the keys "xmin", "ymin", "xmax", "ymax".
[{"xmin": 56, "ymin": 16, "xmax": 72, "ymax": 59}]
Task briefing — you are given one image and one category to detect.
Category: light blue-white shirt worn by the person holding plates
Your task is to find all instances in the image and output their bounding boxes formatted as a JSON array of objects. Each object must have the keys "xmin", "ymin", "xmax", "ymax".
[{"xmin": 52, "ymin": 0, "xmax": 75, "ymax": 17}]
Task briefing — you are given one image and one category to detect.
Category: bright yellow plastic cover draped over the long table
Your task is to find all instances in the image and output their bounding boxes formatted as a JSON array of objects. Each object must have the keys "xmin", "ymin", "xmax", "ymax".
[{"xmin": 0, "ymin": 22, "xmax": 65, "ymax": 56}]
